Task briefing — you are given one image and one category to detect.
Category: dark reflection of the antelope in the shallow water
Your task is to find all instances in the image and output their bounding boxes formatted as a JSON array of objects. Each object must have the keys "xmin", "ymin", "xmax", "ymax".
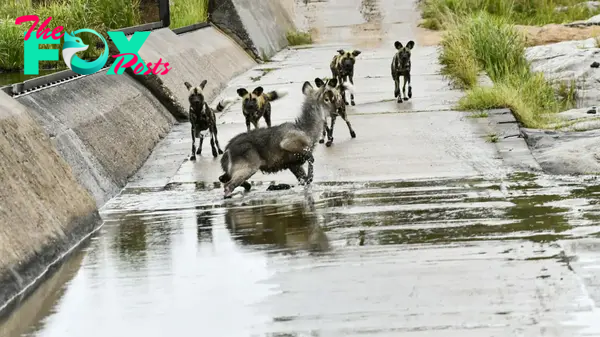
[{"xmin": 225, "ymin": 192, "xmax": 329, "ymax": 251}]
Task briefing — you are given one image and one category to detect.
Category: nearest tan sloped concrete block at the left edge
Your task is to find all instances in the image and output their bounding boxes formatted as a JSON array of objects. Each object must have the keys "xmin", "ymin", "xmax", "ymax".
[{"xmin": 0, "ymin": 92, "xmax": 100, "ymax": 313}]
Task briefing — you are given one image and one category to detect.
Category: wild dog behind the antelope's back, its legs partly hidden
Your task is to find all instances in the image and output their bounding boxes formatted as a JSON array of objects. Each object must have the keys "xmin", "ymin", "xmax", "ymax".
[{"xmin": 237, "ymin": 87, "xmax": 287, "ymax": 131}]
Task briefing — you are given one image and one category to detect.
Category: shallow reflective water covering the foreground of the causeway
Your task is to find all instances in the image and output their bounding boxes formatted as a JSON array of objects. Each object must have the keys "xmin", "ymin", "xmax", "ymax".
[{"xmin": 2, "ymin": 175, "xmax": 600, "ymax": 337}]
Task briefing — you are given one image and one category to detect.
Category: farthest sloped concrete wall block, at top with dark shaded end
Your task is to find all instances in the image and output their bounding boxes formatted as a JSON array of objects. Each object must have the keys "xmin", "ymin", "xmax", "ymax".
[{"xmin": 209, "ymin": 0, "xmax": 296, "ymax": 61}]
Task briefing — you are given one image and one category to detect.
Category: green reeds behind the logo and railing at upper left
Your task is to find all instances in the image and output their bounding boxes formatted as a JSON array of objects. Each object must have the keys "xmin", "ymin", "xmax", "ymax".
[{"xmin": 0, "ymin": 0, "xmax": 208, "ymax": 72}]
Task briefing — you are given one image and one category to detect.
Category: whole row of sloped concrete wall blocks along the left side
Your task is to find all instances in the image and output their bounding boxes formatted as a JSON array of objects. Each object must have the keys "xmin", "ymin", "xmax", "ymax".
[{"xmin": 0, "ymin": 0, "xmax": 294, "ymax": 316}]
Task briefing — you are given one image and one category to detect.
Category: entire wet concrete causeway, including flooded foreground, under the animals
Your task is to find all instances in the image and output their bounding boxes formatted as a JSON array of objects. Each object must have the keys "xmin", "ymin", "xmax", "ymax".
[{"xmin": 0, "ymin": 0, "xmax": 600, "ymax": 337}]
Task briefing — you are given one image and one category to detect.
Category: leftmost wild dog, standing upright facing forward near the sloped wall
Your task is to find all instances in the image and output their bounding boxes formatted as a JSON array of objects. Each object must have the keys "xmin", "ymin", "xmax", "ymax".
[{"xmin": 184, "ymin": 80, "xmax": 234, "ymax": 160}]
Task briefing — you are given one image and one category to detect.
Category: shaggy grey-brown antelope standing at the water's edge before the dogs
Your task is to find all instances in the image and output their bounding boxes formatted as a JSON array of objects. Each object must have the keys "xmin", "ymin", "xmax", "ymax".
[{"xmin": 219, "ymin": 79, "xmax": 352, "ymax": 198}]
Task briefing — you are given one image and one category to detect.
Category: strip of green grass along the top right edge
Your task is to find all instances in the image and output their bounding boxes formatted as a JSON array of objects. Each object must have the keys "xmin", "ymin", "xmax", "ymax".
[{"xmin": 419, "ymin": 0, "xmax": 600, "ymax": 30}]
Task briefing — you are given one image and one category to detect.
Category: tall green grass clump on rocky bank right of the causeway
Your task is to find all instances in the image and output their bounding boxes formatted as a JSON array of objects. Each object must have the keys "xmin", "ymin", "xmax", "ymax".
[{"xmin": 439, "ymin": 12, "xmax": 576, "ymax": 128}]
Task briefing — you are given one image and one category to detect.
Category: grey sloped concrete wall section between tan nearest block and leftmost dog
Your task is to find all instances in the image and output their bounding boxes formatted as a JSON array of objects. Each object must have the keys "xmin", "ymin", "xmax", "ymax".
[{"xmin": 17, "ymin": 71, "xmax": 175, "ymax": 207}]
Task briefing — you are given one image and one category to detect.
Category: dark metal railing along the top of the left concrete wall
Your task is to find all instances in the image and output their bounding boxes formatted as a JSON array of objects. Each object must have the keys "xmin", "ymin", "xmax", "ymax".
[{"xmin": 0, "ymin": 0, "xmax": 210, "ymax": 97}]
